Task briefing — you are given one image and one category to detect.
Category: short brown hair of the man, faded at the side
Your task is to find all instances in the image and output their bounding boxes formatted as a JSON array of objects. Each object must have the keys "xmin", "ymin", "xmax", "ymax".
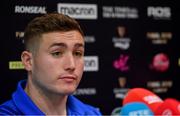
[{"xmin": 24, "ymin": 13, "xmax": 84, "ymax": 53}]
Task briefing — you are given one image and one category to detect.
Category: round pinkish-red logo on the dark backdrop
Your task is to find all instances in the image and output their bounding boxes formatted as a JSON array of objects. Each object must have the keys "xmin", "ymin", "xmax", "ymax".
[{"xmin": 151, "ymin": 53, "xmax": 169, "ymax": 72}]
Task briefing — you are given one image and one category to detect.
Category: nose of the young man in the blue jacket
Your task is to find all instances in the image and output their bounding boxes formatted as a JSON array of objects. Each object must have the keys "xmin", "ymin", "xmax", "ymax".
[{"xmin": 64, "ymin": 54, "xmax": 75, "ymax": 71}]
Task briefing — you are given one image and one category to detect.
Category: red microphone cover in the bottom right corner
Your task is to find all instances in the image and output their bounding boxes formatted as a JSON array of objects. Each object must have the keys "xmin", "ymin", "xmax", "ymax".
[{"xmin": 154, "ymin": 98, "xmax": 180, "ymax": 116}]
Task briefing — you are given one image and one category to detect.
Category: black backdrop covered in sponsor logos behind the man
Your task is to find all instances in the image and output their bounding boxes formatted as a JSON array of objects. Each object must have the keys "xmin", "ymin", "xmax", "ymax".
[{"xmin": 0, "ymin": 0, "xmax": 180, "ymax": 115}]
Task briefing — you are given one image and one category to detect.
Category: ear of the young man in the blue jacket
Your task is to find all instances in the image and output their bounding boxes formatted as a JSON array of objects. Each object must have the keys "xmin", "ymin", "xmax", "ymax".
[{"xmin": 21, "ymin": 51, "xmax": 32, "ymax": 71}]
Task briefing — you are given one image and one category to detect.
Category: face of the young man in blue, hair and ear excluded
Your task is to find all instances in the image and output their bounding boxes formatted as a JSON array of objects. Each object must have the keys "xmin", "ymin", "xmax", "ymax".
[{"xmin": 31, "ymin": 31, "xmax": 84, "ymax": 95}]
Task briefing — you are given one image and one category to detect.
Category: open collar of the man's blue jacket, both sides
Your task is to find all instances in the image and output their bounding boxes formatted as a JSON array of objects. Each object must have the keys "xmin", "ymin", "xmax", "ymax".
[{"xmin": 12, "ymin": 80, "xmax": 86, "ymax": 115}]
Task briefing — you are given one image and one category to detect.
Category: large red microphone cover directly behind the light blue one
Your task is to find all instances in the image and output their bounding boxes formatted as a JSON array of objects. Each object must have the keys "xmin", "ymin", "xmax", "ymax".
[{"xmin": 122, "ymin": 88, "xmax": 163, "ymax": 112}]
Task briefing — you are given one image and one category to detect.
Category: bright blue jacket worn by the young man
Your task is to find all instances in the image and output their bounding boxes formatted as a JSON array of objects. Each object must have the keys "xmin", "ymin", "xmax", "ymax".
[{"xmin": 0, "ymin": 80, "xmax": 101, "ymax": 115}]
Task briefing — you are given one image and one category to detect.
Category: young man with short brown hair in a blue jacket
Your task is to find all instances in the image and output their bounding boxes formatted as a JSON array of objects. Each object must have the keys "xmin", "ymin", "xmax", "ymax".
[{"xmin": 0, "ymin": 13, "xmax": 101, "ymax": 115}]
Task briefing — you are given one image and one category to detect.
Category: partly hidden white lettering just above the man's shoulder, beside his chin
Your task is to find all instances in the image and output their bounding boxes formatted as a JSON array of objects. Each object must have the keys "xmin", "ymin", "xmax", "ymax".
[{"xmin": 73, "ymin": 88, "xmax": 96, "ymax": 95}]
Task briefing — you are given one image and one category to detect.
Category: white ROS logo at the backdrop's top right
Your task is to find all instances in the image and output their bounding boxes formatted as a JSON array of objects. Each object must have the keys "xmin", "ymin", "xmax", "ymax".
[{"xmin": 147, "ymin": 6, "xmax": 171, "ymax": 19}]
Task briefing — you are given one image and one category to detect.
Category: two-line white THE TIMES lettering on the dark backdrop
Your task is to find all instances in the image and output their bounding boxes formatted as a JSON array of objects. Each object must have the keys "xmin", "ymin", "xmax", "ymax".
[{"xmin": 102, "ymin": 6, "xmax": 139, "ymax": 19}]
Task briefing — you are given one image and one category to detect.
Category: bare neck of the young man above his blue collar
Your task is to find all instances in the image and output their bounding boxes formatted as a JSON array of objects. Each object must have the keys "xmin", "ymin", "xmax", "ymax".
[{"xmin": 25, "ymin": 79, "xmax": 67, "ymax": 115}]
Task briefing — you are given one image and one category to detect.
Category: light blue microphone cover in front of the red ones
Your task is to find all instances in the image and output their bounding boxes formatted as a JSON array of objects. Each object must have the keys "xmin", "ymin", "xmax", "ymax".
[{"xmin": 120, "ymin": 102, "xmax": 154, "ymax": 116}]
